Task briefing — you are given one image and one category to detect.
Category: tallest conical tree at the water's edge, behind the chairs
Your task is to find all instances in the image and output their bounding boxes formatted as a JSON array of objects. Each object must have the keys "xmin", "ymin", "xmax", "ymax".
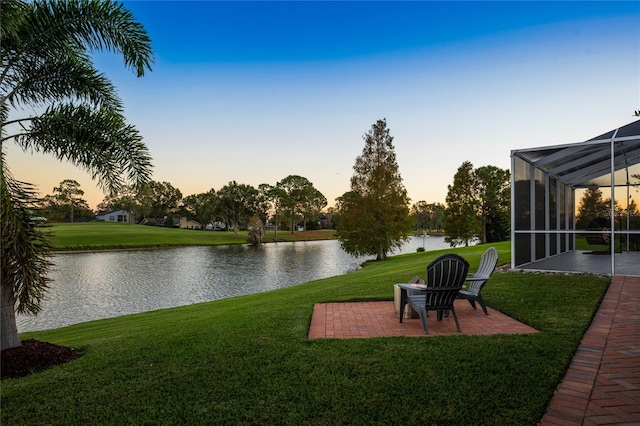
[{"xmin": 337, "ymin": 119, "xmax": 412, "ymax": 260}]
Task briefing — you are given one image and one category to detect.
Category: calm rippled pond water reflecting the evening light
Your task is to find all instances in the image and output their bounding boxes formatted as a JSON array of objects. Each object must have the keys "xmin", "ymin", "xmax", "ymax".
[{"xmin": 17, "ymin": 237, "xmax": 448, "ymax": 332}]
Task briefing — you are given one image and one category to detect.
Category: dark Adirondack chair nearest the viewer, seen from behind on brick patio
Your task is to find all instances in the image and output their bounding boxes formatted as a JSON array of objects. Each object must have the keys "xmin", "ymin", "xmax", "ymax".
[{"xmin": 400, "ymin": 253, "xmax": 469, "ymax": 334}]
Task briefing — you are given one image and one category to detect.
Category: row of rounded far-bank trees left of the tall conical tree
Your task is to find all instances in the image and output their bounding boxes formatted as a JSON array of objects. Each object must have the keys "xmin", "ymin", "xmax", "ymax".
[{"xmin": 34, "ymin": 175, "xmax": 327, "ymax": 233}]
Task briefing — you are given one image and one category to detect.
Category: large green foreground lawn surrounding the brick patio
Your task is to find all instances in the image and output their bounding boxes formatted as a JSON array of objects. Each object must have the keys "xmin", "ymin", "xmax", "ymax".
[{"xmin": 0, "ymin": 242, "xmax": 609, "ymax": 425}]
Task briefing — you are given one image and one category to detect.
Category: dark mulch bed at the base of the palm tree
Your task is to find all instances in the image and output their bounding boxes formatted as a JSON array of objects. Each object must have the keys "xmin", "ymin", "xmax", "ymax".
[{"xmin": 0, "ymin": 339, "xmax": 83, "ymax": 379}]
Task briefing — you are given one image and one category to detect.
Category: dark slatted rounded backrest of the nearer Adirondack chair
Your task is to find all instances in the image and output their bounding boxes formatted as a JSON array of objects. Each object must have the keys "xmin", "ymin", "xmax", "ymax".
[{"xmin": 425, "ymin": 253, "xmax": 469, "ymax": 310}]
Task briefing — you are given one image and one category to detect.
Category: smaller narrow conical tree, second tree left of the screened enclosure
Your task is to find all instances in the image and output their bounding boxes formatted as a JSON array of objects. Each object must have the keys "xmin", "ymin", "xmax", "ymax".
[{"xmin": 444, "ymin": 161, "xmax": 482, "ymax": 247}]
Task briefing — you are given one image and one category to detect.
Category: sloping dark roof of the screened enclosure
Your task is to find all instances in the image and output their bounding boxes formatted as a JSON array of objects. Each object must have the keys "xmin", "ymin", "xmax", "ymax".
[{"xmin": 511, "ymin": 120, "xmax": 640, "ymax": 188}]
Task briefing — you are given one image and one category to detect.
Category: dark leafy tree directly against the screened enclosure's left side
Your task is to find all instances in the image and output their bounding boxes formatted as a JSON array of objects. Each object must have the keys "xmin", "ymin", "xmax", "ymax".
[{"xmin": 474, "ymin": 166, "xmax": 511, "ymax": 243}]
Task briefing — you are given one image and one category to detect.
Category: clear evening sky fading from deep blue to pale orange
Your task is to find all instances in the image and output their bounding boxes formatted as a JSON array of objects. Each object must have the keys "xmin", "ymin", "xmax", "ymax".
[{"xmin": 7, "ymin": 1, "xmax": 640, "ymax": 208}]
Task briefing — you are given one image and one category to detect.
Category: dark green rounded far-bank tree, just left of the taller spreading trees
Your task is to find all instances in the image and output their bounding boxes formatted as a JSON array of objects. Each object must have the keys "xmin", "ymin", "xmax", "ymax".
[{"xmin": 218, "ymin": 180, "xmax": 258, "ymax": 235}]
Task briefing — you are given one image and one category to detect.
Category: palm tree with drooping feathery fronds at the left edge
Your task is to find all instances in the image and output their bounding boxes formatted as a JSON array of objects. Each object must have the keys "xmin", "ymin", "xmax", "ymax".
[{"xmin": 0, "ymin": 0, "xmax": 153, "ymax": 349}]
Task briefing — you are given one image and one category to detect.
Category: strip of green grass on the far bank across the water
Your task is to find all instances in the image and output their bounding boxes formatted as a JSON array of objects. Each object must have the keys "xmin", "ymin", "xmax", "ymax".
[{"xmin": 47, "ymin": 222, "xmax": 334, "ymax": 250}]
